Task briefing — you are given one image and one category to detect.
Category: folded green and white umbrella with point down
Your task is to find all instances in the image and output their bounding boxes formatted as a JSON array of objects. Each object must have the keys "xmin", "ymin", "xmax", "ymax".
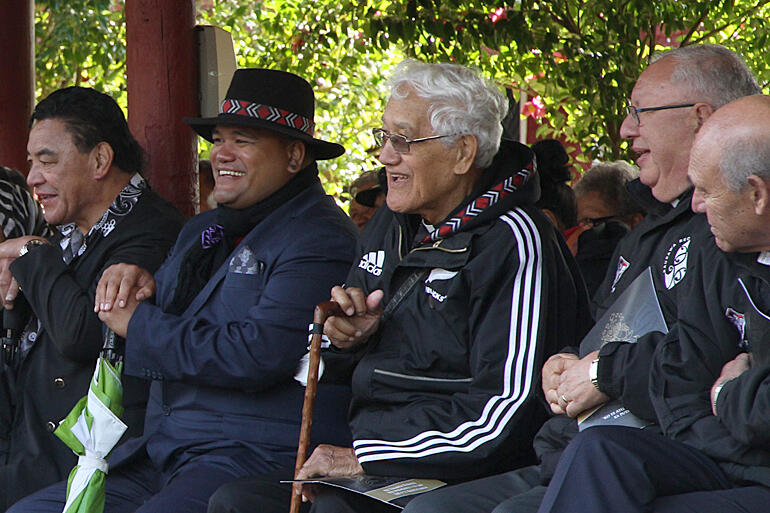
[{"xmin": 54, "ymin": 330, "xmax": 127, "ymax": 513}]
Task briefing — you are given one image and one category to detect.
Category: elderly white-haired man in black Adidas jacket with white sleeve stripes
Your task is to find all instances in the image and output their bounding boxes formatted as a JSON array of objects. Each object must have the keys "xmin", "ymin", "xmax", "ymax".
[{"xmin": 204, "ymin": 60, "xmax": 589, "ymax": 512}]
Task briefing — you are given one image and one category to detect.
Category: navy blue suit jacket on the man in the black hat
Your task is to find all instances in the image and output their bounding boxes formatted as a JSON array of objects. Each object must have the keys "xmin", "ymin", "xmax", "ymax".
[{"xmin": 110, "ymin": 182, "xmax": 357, "ymax": 474}]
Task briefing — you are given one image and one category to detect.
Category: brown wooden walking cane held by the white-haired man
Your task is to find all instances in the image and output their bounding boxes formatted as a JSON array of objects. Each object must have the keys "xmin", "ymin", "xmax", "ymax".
[{"xmin": 289, "ymin": 301, "xmax": 345, "ymax": 513}]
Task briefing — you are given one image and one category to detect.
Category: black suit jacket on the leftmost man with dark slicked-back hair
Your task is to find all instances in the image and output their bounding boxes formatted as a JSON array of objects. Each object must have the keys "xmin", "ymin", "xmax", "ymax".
[{"xmin": 0, "ymin": 190, "xmax": 184, "ymax": 510}]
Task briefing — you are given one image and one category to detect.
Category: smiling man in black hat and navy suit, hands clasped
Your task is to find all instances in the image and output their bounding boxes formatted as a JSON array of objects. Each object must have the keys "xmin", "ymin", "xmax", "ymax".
[{"xmin": 9, "ymin": 69, "xmax": 357, "ymax": 513}]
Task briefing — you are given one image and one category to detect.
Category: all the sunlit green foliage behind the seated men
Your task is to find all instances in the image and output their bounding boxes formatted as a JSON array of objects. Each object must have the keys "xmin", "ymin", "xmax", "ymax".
[{"xmin": 35, "ymin": 0, "xmax": 770, "ymax": 188}]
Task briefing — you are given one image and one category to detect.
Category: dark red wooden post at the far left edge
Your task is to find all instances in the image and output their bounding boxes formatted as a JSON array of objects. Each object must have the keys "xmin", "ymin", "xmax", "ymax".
[{"xmin": 0, "ymin": 0, "xmax": 35, "ymax": 174}]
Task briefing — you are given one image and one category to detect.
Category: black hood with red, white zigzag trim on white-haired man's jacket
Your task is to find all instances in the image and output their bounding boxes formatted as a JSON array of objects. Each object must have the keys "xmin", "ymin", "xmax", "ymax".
[{"xmin": 416, "ymin": 139, "xmax": 540, "ymax": 242}]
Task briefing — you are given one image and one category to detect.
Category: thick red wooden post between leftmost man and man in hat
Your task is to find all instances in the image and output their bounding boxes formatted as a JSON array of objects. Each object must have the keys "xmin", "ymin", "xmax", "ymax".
[{"xmin": 125, "ymin": 0, "xmax": 198, "ymax": 216}]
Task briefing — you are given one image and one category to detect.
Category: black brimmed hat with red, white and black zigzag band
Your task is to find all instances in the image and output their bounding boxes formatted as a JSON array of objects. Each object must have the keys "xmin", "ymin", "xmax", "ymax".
[{"xmin": 184, "ymin": 68, "xmax": 345, "ymax": 160}]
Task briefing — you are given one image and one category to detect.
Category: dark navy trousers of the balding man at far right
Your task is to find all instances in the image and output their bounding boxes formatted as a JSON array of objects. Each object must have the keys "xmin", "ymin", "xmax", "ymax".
[{"xmin": 539, "ymin": 426, "xmax": 770, "ymax": 513}]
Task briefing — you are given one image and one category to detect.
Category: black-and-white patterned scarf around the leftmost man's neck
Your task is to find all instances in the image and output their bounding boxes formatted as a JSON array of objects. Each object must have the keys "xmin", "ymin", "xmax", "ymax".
[{"xmin": 57, "ymin": 173, "xmax": 149, "ymax": 264}]
